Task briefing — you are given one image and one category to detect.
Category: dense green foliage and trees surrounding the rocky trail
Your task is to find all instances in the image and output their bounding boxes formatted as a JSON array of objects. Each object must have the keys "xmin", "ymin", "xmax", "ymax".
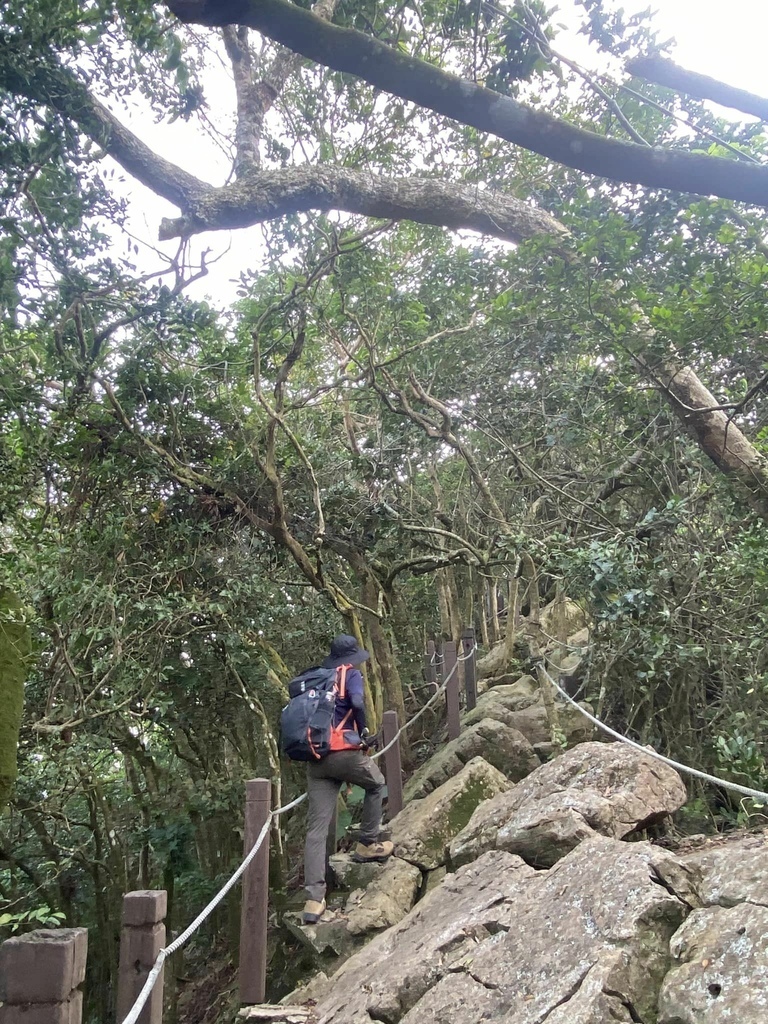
[{"xmin": 0, "ymin": 0, "xmax": 768, "ymax": 1020}]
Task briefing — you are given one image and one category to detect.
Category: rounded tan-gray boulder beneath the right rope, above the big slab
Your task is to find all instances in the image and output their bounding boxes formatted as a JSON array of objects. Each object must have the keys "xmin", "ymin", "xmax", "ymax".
[{"xmin": 450, "ymin": 743, "xmax": 686, "ymax": 867}]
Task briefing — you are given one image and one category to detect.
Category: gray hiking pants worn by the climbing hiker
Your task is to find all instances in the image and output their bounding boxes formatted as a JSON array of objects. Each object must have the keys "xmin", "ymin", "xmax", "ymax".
[{"xmin": 304, "ymin": 751, "xmax": 384, "ymax": 903}]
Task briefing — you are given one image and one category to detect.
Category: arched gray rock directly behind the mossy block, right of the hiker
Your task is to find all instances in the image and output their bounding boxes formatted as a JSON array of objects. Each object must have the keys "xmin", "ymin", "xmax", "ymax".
[{"xmin": 403, "ymin": 718, "xmax": 541, "ymax": 801}]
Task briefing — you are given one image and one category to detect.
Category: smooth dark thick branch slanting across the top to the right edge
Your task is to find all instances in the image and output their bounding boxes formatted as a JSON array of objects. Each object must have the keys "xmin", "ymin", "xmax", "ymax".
[{"xmin": 168, "ymin": 0, "xmax": 768, "ymax": 206}]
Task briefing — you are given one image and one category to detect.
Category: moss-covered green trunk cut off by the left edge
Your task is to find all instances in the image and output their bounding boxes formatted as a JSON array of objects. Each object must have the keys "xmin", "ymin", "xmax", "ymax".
[{"xmin": 0, "ymin": 587, "xmax": 31, "ymax": 811}]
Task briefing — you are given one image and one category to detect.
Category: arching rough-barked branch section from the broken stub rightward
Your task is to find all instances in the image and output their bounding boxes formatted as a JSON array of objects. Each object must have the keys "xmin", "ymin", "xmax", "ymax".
[{"xmin": 160, "ymin": 166, "xmax": 566, "ymax": 242}]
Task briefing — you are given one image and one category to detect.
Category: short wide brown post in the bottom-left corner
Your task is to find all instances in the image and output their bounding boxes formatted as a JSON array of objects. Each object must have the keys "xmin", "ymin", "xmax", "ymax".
[{"xmin": 0, "ymin": 928, "xmax": 88, "ymax": 1024}]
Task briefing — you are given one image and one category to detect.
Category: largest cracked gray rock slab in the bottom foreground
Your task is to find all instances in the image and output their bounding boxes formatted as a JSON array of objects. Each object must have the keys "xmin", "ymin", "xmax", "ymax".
[{"xmin": 315, "ymin": 838, "xmax": 694, "ymax": 1024}]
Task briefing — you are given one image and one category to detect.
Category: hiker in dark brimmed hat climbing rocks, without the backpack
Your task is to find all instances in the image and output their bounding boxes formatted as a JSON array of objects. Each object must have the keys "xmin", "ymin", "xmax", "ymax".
[{"xmin": 302, "ymin": 634, "xmax": 394, "ymax": 925}]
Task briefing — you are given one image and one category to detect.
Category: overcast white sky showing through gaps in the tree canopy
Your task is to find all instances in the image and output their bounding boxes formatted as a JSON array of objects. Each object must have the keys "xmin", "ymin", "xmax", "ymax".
[{"xmin": 116, "ymin": 0, "xmax": 768, "ymax": 306}]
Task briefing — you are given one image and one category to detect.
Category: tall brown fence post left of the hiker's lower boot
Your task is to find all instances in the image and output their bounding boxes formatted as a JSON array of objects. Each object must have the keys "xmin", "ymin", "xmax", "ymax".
[{"xmin": 240, "ymin": 778, "xmax": 271, "ymax": 1006}]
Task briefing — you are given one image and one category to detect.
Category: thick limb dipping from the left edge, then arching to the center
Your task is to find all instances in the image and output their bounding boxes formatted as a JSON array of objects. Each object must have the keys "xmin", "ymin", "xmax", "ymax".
[{"xmin": 0, "ymin": 40, "xmax": 566, "ymax": 242}]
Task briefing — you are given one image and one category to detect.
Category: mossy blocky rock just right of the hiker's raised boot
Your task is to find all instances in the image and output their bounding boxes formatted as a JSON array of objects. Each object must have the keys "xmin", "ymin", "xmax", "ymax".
[{"xmin": 390, "ymin": 758, "xmax": 510, "ymax": 870}]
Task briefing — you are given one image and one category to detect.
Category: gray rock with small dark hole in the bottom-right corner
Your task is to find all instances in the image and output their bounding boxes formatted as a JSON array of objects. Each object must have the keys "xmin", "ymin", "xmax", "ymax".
[{"xmin": 658, "ymin": 903, "xmax": 768, "ymax": 1024}]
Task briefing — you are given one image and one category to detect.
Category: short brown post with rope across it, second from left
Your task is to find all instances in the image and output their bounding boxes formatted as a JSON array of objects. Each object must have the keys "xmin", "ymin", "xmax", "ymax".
[{"xmin": 118, "ymin": 889, "xmax": 168, "ymax": 1024}]
